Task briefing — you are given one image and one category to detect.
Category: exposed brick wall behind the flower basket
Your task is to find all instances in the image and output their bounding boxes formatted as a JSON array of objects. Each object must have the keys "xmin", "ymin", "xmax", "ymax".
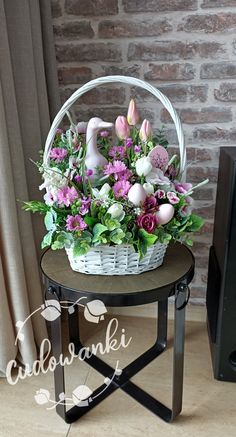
[{"xmin": 51, "ymin": 0, "xmax": 236, "ymax": 304}]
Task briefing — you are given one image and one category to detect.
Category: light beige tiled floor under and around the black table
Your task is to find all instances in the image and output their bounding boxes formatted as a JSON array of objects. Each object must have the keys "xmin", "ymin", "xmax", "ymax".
[{"xmin": 0, "ymin": 316, "xmax": 236, "ymax": 437}]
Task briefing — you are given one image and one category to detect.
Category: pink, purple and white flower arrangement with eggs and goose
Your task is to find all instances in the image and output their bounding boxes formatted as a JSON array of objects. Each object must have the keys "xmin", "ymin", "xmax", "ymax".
[{"xmin": 23, "ymin": 100, "xmax": 205, "ymax": 258}]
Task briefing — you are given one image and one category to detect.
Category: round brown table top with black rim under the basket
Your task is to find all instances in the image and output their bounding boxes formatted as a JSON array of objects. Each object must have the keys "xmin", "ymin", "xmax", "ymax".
[{"xmin": 41, "ymin": 243, "xmax": 194, "ymax": 297}]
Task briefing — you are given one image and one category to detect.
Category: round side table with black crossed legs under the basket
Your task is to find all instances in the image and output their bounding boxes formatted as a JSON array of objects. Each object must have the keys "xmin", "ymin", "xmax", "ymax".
[{"xmin": 41, "ymin": 243, "xmax": 194, "ymax": 423}]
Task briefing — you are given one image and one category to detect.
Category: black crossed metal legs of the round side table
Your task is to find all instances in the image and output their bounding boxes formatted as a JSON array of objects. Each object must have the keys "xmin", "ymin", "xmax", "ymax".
[{"xmin": 48, "ymin": 281, "xmax": 188, "ymax": 423}]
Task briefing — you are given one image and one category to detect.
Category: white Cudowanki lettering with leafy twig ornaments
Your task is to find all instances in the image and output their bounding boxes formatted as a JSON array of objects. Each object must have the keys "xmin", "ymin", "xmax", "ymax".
[{"xmin": 6, "ymin": 296, "xmax": 132, "ymax": 410}]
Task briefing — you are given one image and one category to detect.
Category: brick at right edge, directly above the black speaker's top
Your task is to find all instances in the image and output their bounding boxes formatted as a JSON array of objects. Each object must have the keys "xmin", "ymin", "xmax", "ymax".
[{"xmin": 193, "ymin": 127, "xmax": 236, "ymax": 145}]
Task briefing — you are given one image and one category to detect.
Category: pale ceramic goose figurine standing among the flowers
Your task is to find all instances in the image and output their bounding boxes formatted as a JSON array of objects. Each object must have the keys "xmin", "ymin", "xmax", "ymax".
[{"xmin": 85, "ymin": 117, "xmax": 113, "ymax": 175}]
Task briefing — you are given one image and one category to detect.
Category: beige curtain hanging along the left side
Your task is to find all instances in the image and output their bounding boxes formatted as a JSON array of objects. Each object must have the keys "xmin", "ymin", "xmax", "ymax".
[{"xmin": 0, "ymin": 0, "xmax": 59, "ymax": 375}]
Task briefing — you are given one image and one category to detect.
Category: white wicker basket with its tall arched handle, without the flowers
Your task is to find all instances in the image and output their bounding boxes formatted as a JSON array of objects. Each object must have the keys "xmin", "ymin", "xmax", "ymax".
[{"xmin": 43, "ymin": 76, "xmax": 186, "ymax": 275}]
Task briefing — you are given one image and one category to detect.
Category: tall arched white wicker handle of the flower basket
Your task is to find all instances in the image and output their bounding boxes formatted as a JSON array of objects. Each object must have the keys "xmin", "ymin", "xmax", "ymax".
[{"xmin": 43, "ymin": 76, "xmax": 186, "ymax": 174}]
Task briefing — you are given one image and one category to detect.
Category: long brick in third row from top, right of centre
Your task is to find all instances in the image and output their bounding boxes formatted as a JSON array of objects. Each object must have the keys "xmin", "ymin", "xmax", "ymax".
[{"xmin": 128, "ymin": 40, "xmax": 226, "ymax": 61}]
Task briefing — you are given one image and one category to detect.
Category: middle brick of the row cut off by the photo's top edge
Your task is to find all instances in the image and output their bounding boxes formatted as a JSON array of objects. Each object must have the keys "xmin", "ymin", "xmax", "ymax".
[{"xmin": 123, "ymin": 0, "xmax": 197, "ymax": 13}]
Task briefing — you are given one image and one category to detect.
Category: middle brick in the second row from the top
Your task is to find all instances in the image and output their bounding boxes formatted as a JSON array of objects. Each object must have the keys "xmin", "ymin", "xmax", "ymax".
[{"xmin": 98, "ymin": 19, "xmax": 172, "ymax": 38}]
